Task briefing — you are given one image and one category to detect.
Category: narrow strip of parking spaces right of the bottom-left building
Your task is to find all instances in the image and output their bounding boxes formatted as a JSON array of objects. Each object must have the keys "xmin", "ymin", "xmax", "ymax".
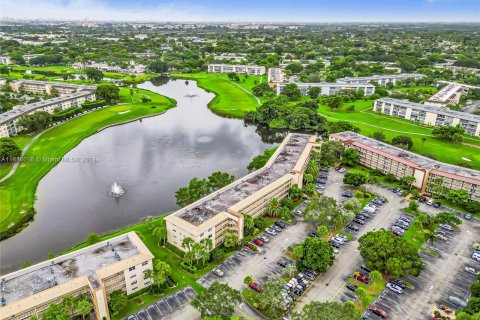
[{"xmin": 126, "ymin": 287, "xmax": 197, "ymax": 320}]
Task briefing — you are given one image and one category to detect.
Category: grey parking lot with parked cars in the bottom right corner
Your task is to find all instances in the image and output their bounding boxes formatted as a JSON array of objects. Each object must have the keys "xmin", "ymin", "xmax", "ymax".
[{"xmin": 369, "ymin": 221, "xmax": 480, "ymax": 320}]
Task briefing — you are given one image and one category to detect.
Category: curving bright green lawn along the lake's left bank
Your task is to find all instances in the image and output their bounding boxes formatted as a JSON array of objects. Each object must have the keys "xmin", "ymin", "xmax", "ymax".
[{"xmin": 0, "ymin": 88, "xmax": 175, "ymax": 236}]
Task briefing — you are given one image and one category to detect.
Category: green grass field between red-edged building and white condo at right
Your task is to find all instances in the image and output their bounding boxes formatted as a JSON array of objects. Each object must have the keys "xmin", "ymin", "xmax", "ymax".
[{"xmin": 319, "ymin": 100, "xmax": 480, "ymax": 170}]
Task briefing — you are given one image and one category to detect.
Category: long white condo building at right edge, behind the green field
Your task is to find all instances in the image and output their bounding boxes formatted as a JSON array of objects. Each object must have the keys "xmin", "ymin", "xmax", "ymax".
[{"xmin": 373, "ymin": 98, "xmax": 480, "ymax": 136}]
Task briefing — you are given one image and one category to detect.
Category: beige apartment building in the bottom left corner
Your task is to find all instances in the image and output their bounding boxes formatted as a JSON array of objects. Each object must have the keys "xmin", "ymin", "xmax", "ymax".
[{"xmin": 0, "ymin": 232, "xmax": 153, "ymax": 320}]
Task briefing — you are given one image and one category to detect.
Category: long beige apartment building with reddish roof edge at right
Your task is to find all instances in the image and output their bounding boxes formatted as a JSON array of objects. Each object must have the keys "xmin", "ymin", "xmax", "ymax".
[{"xmin": 330, "ymin": 131, "xmax": 480, "ymax": 201}]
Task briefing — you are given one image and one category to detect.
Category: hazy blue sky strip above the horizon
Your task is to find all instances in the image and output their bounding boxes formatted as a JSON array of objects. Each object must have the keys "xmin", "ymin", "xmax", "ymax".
[{"xmin": 0, "ymin": 0, "xmax": 480, "ymax": 23}]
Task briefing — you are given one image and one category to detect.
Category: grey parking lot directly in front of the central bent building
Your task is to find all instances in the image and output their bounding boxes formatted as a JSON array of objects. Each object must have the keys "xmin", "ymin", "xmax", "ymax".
[{"xmin": 197, "ymin": 222, "xmax": 313, "ymax": 290}]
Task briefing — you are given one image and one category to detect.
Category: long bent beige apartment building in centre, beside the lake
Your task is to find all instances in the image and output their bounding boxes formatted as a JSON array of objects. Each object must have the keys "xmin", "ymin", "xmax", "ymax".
[{"xmin": 165, "ymin": 133, "xmax": 318, "ymax": 250}]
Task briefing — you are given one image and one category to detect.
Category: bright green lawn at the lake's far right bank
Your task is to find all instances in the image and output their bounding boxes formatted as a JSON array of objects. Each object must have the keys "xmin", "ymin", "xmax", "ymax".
[{"xmin": 171, "ymin": 72, "xmax": 260, "ymax": 118}]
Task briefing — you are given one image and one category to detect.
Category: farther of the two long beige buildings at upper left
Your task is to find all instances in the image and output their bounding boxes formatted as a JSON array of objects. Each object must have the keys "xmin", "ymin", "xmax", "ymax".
[{"xmin": 10, "ymin": 80, "xmax": 97, "ymax": 95}]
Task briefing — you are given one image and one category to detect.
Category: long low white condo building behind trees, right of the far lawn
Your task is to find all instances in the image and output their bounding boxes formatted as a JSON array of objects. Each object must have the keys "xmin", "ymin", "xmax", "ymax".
[{"xmin": 277, "ymin": 82, "xmax": 375, "ymax": 96}]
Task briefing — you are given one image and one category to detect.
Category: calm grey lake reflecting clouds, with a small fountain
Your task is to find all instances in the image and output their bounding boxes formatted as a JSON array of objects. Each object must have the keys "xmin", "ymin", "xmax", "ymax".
[{"xmin": 0, "ymin": 79, "xmax": 283, "ymax": 274}]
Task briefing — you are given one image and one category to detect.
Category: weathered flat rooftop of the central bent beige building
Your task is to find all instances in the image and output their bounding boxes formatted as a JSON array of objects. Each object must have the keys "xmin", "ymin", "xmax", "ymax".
[{"xmin": 175, "ymin": 133, "xmax": 311, "ymax": 226}]
